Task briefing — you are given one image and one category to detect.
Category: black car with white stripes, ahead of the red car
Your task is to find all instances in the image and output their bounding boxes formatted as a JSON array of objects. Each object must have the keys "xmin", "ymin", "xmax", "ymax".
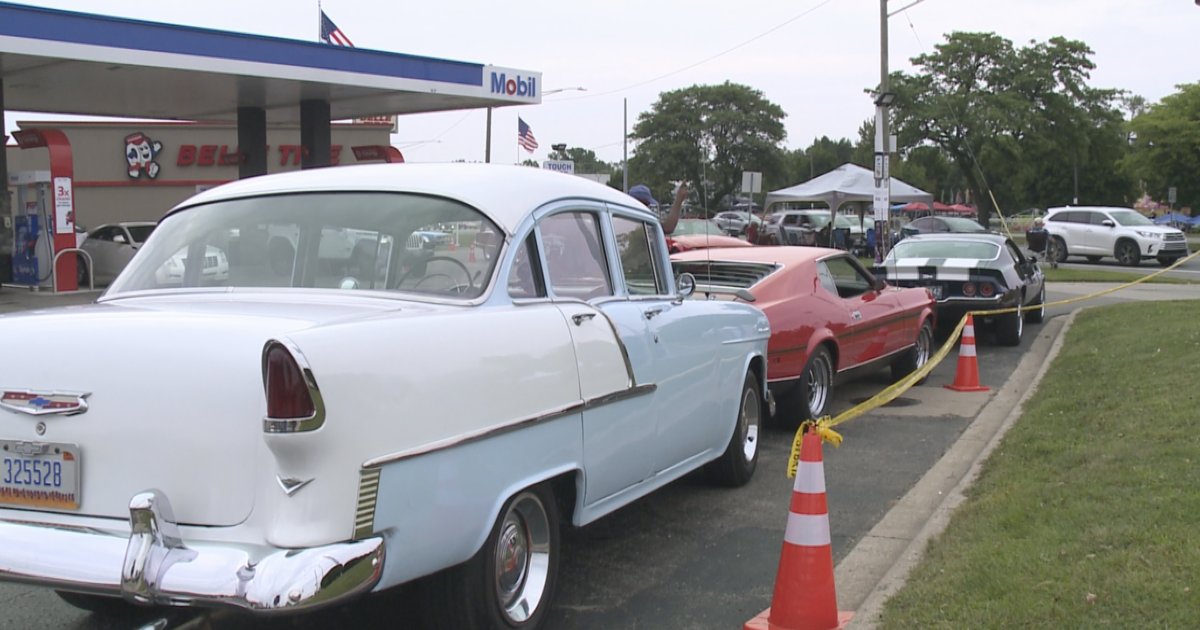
[{"xmin": 876, "ymin": 233, "xmax": 1046, "ymax": 346}]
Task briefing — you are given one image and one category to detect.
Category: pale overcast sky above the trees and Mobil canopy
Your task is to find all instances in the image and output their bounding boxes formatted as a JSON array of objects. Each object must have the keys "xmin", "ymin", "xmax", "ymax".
[{"xmin": 7, "ymin": 0, "xmax": 1200, "ymax": 169}]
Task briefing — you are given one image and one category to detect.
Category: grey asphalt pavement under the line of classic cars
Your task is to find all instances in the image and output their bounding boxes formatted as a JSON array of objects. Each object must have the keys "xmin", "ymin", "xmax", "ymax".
[{"xmin": 0, "ymin": 284, "xmax": 1200, "ymax": 630}]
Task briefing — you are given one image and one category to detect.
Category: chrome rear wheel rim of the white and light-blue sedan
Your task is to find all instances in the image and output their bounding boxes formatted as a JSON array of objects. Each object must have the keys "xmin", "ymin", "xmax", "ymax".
[{"xmin": 493, "ymin": 492, "xmax": 550, "ymax": 624}]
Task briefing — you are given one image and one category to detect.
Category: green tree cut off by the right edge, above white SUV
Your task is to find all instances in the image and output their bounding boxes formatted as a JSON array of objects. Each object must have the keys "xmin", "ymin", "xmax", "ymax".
[{"xmin": 1127, "ymin": 83, "xmax": 1200, "ymax": 214}]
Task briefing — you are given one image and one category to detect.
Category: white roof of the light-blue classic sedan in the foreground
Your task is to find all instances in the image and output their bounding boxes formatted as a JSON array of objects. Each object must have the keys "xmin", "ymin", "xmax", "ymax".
[{"xmin": 172, "ymin": 163, "xmax": 653, "ymax": 235}]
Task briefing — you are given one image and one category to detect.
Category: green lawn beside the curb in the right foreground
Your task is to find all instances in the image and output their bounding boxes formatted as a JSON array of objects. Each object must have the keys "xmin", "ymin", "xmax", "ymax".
[{"xmin": 881, "ymin": 301, "xmax": 1200, "ymax": 630}]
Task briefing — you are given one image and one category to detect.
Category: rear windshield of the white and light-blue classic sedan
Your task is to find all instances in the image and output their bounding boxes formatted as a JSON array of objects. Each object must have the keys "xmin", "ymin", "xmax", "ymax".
[{"xmin": 108, "ymin": 192, "xmax": 504, "ymax": 299}]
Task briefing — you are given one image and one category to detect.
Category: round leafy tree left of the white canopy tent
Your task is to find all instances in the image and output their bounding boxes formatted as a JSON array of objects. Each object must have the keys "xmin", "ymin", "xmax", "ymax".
[{"xmin": 629, "ymin": 82, "xmax": 787, "ymax": 211}]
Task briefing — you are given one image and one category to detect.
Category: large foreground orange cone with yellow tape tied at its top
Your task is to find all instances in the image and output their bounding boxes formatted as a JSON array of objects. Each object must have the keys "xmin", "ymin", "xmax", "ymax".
[{"xmin": 743, "ymin": 432, "xmax": 854, "ymax": 630}]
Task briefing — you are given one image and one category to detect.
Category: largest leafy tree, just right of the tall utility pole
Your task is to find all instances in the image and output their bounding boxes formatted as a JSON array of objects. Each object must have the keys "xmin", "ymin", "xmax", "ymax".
[{"xmin": 892, "ymin": 32, "xmax": 1136, "ymax": 224}]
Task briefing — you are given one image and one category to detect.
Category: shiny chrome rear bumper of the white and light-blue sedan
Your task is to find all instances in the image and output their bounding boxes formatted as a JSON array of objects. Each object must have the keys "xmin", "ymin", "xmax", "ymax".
[{"xmin": 0, "ymin": 490, "xmax": 384, "ymax": 613}]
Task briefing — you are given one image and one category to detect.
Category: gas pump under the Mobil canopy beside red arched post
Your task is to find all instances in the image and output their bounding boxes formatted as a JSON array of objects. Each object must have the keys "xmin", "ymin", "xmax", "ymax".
[{"xmin": 8, "ymin": 170, "xmax": 64, "ymax": 288}]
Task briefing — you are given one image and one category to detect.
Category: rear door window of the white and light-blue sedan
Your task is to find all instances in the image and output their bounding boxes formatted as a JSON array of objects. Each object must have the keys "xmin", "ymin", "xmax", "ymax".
[{"xmin": 539, "ymin": 211, "xmax": 612, "ymax": 300}]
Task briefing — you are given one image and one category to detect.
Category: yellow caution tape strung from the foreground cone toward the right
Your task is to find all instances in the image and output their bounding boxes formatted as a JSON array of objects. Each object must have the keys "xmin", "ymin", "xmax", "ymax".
[{"xmin": 787, "ymin": 250, "xmax": 1200, "ymax": 479}]
